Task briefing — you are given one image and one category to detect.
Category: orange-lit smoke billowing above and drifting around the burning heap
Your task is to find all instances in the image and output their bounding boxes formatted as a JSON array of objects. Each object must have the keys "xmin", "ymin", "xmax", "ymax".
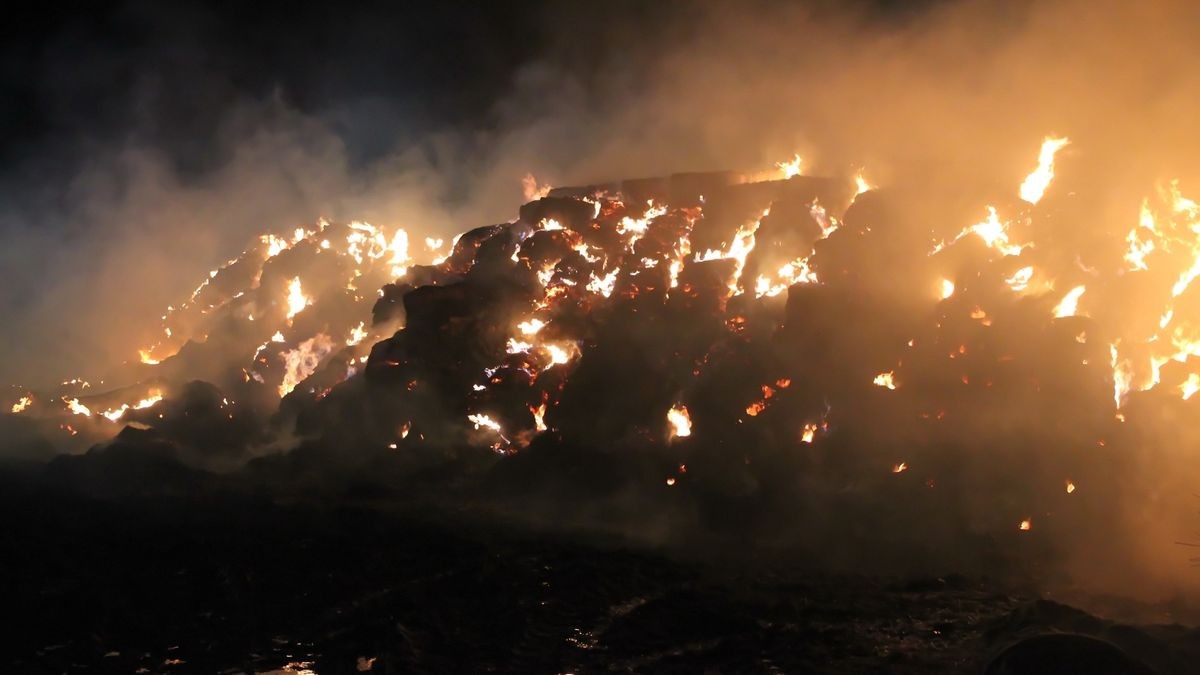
[{"xmin": 7, "ymin": 0, "xmax": 1200, "ymax": 610}]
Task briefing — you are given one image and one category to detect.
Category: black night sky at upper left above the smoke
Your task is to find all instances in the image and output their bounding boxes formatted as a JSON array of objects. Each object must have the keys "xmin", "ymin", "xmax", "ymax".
[{"xmin": 0, "ymin": 0, "xmax": 544, "ymax": 178}]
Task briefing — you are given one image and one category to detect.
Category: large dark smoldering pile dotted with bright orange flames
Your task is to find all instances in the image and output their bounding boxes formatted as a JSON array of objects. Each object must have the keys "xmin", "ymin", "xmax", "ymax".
[{"xmin": 5, "ymin": 140, "xmax": 1194, "ymax": 566}]
